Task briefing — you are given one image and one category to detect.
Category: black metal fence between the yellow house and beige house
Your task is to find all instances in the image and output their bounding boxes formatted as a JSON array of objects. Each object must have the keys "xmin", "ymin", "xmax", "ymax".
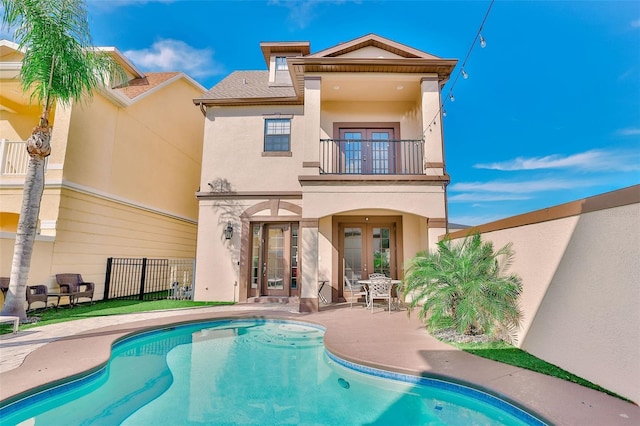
[{"xmin": 104, "ymin": 257, "xmax": 195, "ymax": 300}]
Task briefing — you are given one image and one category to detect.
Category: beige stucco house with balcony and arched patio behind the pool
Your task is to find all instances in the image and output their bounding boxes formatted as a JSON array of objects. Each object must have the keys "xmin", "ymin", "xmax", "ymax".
[{"xmin": 194, "ymin": 34, "xmax": 457, "ymax": 310}]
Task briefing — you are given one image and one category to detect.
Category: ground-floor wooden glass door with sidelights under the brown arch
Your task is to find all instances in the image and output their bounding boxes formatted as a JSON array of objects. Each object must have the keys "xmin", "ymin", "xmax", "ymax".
[{"xmin": 250, "ymin": 223, "xmax": 299, "ymax": 296}]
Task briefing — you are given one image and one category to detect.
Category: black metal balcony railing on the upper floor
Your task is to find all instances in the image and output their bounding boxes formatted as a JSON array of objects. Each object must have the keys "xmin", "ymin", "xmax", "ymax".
[{"xmin": 320, "ymin": 139, "xmax": 424, "ymax": 175}]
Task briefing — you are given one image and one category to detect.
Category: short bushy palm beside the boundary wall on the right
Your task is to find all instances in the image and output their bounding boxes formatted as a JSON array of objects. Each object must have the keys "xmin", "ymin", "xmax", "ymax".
[{"xmin": 403, "ymin": 234, "xmax": 522, "ymax": 339}]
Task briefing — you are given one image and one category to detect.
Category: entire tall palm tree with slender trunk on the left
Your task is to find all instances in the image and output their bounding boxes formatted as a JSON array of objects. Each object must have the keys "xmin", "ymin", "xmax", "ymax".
[{"xmin": 0, "ymin": 0, "xmax": 126, "ymax": 321}]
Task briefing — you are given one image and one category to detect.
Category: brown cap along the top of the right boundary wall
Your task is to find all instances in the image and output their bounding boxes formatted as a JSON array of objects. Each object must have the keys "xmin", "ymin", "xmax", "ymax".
[{"xmin": 440, "ymin": 185, "xmax": 640, "ymax": 239}]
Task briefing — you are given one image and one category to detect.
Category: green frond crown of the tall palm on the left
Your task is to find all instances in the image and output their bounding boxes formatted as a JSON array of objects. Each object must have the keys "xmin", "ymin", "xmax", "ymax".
[{"xmin": 2, "ymin": 0, "xmax": 124, "ymax": 110}]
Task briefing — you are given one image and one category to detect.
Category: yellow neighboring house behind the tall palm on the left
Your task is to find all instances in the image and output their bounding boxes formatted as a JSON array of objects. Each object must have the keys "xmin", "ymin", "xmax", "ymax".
[{"xmin": 0, "ymin": 40, "xmax": 205, "ymax": 299}]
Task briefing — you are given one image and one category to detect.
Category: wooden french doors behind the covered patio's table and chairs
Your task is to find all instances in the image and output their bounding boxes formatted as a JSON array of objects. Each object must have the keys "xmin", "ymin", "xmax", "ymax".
[{"xmin": 338, "ymin": 223, "xmax": 397, "ymax": 281}]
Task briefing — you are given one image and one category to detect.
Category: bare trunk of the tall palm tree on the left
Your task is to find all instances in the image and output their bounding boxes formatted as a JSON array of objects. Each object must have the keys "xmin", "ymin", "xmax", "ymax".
[{"xmin": 0, "ymin": 125, "xmax": 51, "ymax": 322}]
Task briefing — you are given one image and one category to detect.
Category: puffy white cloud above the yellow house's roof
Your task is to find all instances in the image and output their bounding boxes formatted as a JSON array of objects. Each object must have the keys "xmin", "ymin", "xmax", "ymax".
[{"xmin": 124, "ymin": 39, "xmax": 222, "ymax": 78}]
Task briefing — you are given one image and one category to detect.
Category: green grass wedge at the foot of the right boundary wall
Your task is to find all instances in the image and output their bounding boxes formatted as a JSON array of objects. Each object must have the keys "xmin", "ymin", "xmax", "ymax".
[{"xmin": 447, "ymin": 341, "xmax": 631, "ymax": 402}]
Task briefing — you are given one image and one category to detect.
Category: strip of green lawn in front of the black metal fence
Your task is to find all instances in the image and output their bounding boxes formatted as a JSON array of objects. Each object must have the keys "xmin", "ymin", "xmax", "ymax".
[{"xmin": 0, "ymin": 299, "xmax": 233, "ymax": 334}]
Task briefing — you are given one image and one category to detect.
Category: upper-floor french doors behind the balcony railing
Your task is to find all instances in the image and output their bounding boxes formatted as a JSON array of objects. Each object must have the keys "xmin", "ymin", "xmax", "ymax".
[{"xmin": 340, "ymin": 128, "xmax": 396, "ymax": 174}]
